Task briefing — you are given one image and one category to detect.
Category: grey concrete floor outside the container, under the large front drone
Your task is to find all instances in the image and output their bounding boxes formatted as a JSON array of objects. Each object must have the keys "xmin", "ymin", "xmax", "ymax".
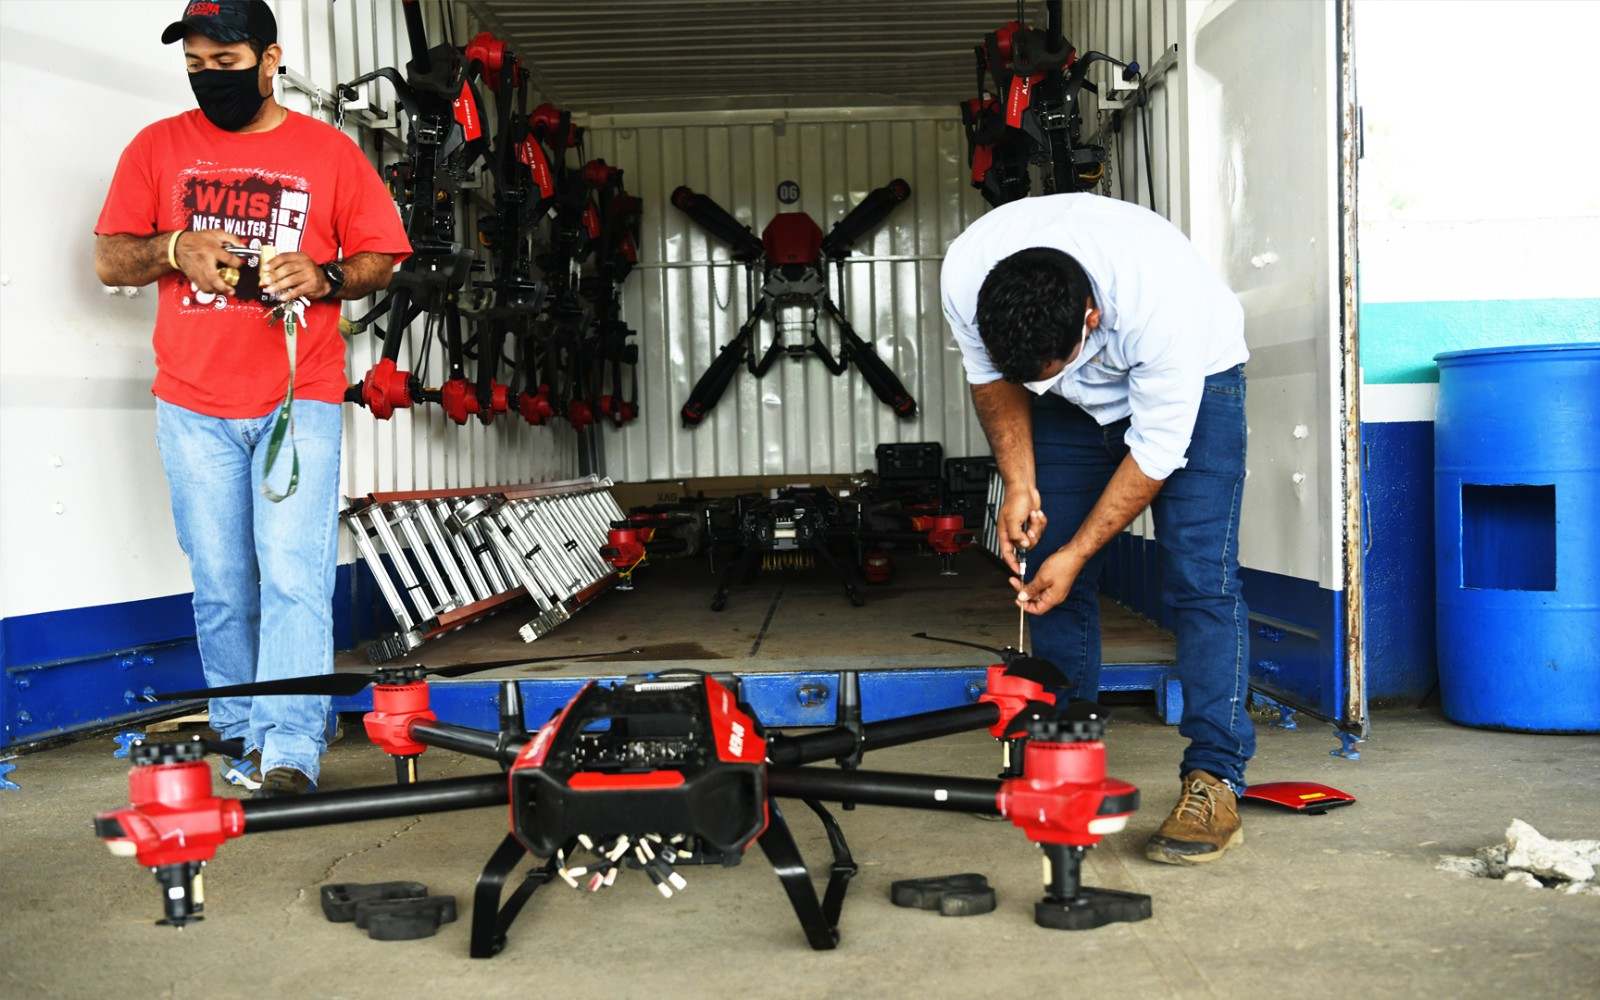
[{"xmin": 0, "ymin": 706, "xmax": 1600, "ymax": 1000}]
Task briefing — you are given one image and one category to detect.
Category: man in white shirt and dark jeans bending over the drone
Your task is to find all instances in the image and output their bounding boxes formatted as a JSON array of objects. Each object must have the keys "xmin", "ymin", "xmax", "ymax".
[{"xmin": 939, "ymin": 194, "xmax": 1256, "ymax": 864}]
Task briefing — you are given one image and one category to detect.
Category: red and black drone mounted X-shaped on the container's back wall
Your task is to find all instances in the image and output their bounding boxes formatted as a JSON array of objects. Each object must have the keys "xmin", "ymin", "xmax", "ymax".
[{"xmin": 672, "ymin": 178, "xmax": 917, "ymax": 427}]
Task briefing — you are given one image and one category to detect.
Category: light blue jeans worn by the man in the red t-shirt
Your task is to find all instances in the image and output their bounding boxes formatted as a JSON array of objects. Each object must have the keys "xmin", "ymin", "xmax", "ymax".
[{"xmin": 155, "ymin": 400, "xmax": 342, "ymax": 782}]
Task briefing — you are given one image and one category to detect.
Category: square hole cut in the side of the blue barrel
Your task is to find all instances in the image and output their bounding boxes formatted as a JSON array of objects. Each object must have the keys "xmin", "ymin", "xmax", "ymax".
[{"xmin": 1461, "ymin": 483, "xmax": 1555, "ymax": 590}]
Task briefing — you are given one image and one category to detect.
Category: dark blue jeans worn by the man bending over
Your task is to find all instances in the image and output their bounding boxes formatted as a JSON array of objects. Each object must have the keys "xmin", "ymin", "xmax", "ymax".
[{"xmin": 1029, "ymin": 365, "xmax": 1256, "ymax": 792}]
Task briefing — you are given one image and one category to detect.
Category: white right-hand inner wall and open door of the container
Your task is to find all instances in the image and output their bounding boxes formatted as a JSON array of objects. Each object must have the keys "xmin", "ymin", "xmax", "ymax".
[{"xmin": 1066, "ymin": 0, "xmax": 1344, "ymax": 590}]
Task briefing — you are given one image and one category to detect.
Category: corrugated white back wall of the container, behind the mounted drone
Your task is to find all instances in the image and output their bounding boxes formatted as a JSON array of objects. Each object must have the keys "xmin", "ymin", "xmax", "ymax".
[{"xmin": 589, "ymin": 106, "xmax": 989, "ymax": 480}]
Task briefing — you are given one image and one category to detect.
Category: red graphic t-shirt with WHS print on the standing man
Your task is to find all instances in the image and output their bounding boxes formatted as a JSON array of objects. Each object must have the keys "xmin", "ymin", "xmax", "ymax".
[{"xmin": 94, "ymin": 110, "xmax": 411, "ymax": 418}]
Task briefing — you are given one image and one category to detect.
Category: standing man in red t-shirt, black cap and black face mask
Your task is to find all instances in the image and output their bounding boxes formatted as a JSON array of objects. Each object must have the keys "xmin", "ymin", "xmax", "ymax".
[{"xmin": 94, "ymin": 0, "xmax": 411, "ymax": 797}]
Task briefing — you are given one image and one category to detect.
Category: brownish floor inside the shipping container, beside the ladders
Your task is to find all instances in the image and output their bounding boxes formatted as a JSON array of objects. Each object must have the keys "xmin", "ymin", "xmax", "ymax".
[{"xmin": 339, "ymin": 552, "xmax": 1173, "ymax": 677}]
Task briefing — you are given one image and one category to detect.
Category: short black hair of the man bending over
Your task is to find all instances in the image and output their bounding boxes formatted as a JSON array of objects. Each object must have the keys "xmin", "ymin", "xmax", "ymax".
[{"xmin": 974, "ymin": 246, "xmax": 1094, "ymax": 382}]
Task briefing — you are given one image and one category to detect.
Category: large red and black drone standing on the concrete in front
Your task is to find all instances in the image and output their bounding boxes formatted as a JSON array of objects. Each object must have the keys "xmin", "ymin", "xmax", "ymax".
[{"xmin": 94, "ymin": 650, "xmax": 1150, "ymax": 958}]
